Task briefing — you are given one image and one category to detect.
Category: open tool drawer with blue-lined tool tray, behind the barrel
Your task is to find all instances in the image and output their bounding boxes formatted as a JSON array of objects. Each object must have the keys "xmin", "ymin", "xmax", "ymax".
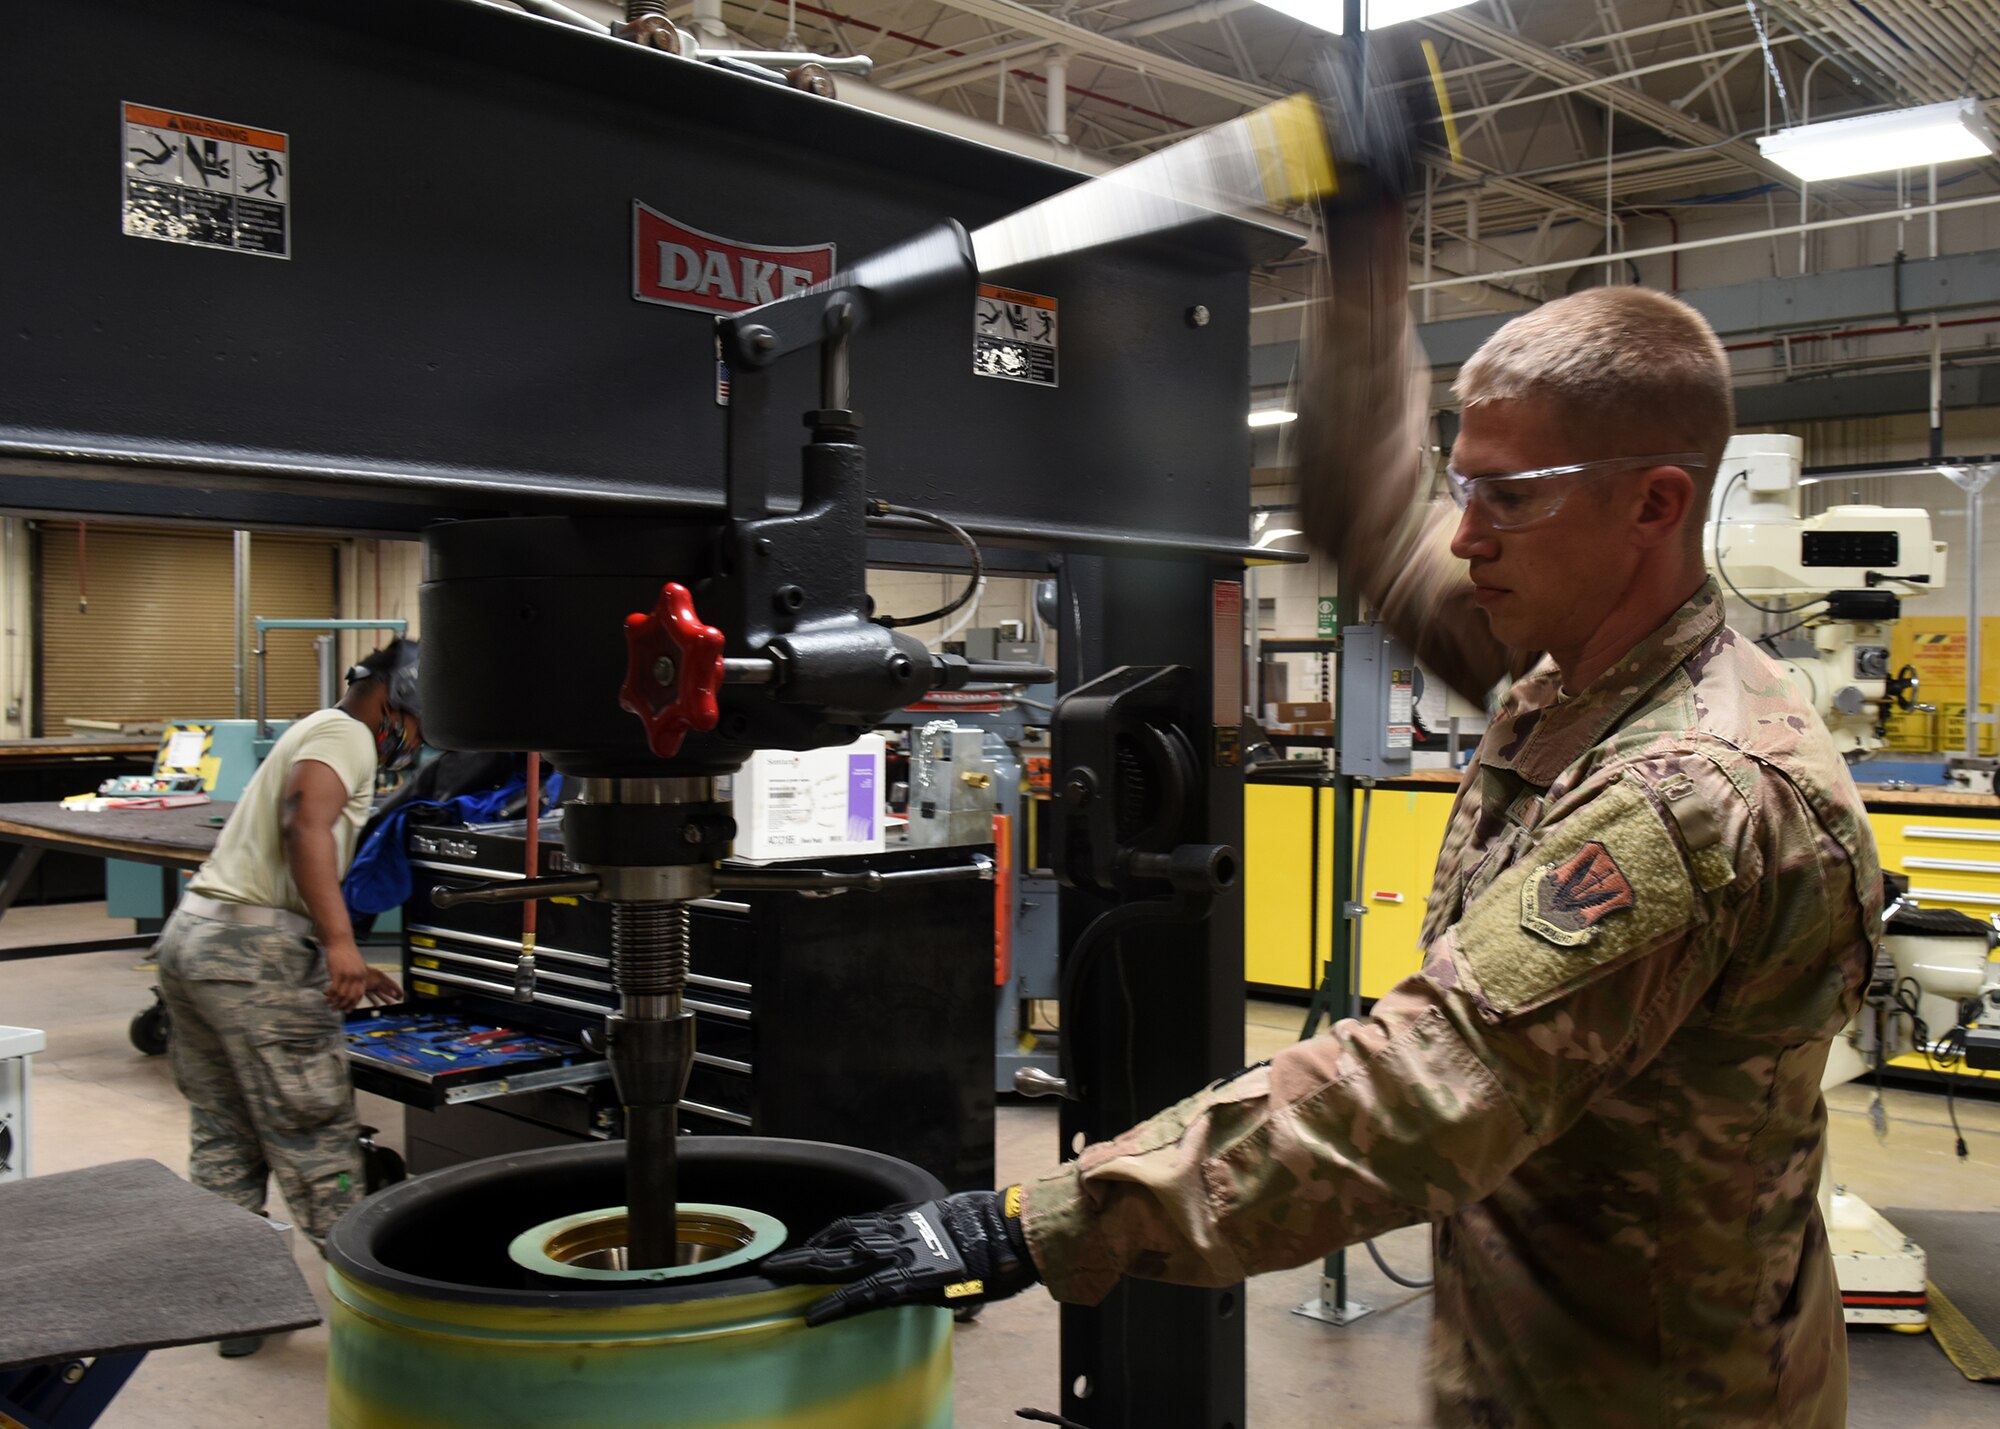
[{"xmin": 346, "ymin": 1003, "xmax": 612, "ymax": 1111}]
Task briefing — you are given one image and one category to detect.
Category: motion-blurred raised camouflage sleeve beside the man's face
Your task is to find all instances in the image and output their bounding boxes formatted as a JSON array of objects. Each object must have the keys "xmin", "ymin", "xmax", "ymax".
[{"xmin": 1296, "ymin": 208, "xmax": 1510, "ymax": 704}]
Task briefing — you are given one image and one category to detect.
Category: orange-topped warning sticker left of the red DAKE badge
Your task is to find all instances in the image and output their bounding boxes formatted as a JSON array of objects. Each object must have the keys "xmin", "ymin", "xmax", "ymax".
[{"xmin": 120, "ymin": 104, "xmax": 292, "ymax": 258}]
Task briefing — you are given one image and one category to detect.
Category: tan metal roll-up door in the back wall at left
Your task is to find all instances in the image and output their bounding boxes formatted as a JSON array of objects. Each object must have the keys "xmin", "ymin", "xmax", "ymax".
[{"xmin": 36, "ymin": 522, "xmax": 338, "ymax": 735}]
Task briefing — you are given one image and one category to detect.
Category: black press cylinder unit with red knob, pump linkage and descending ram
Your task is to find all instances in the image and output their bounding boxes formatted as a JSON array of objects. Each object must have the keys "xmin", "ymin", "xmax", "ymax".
[{"xmin": 422, "ymin": 224, "xmax": 1054, "ymax": 1269}]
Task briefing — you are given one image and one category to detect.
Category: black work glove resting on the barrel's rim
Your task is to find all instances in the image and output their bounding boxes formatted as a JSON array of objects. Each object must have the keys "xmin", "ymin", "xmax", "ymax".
[{"xmin": 758, "ymin": 1187, "xmax": 1042, "ymax": 1325}]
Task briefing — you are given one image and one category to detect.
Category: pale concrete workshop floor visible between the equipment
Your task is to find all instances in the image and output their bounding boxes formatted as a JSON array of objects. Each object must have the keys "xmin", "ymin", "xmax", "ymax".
[{"xmin": 0, "ymin": 905, "xmax": 2000, "ymax": 1429}]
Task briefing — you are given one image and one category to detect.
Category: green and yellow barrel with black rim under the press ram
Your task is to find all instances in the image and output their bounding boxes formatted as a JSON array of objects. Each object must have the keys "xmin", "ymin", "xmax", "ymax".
[{"xmin": 326, "ymin": 1137, "xmax": 952, "ymax": 1429}]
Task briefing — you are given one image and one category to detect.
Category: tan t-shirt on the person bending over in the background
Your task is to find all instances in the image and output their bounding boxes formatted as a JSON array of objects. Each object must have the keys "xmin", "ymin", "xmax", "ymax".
[{"xmin": 188, "ymin": 710, "xmax": 376, "ymax": 917}]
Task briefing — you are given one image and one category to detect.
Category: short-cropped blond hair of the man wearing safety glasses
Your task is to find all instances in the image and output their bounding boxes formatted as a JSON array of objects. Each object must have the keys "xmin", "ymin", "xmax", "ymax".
[{"xmin": 1452, "ymin": 288, "xmax": 1736, "ymax": 482}]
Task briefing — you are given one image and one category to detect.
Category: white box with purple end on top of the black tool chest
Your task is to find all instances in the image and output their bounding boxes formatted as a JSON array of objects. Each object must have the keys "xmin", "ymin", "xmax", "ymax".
[{"xmin": 718, "ymin": 735, "xmax": 888, "ymax": 859}]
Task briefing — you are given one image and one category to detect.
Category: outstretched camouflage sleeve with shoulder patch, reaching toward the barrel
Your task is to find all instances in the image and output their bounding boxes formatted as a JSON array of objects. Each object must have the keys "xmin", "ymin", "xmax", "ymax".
[{"xmin": 1024, "ymin": 757, "xmax": 1776, "ymax": 1303}]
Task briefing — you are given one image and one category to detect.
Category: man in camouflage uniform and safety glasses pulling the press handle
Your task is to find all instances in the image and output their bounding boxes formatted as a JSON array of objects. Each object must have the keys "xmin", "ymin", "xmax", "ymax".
[{"xmin": 1024, "ymin": 214, "xmax": 1880, "ymax": 1429}]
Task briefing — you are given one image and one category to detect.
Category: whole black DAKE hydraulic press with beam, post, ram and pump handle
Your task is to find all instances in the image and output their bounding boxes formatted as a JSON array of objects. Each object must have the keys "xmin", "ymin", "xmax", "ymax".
[{"xmin": 0, "ymin": 0, "xmax": 1408, "ymax": 1408}]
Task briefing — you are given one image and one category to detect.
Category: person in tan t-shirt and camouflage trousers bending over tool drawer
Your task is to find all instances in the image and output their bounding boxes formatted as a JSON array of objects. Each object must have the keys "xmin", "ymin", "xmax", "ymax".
[{"xmin": 158, "ymin": 640, "xmax": 424, "ymax": 1357}]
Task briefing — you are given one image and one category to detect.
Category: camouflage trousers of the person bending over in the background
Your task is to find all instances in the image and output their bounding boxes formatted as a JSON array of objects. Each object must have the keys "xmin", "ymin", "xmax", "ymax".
[{"xmin": 160, "ymin": 911, "xmax": 364, "ymax": 1247}]
